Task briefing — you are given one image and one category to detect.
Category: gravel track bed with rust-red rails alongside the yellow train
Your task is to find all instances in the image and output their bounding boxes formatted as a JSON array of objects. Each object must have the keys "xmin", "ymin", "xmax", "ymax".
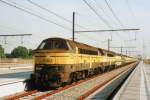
[{"xmin": 6, "ymin": 63, "xmax": 137, "ymax": 100}]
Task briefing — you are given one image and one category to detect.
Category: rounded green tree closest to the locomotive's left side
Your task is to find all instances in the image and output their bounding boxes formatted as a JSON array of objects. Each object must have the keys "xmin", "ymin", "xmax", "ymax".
[{"xmin": 11, "ymin": 46, "xmax": 29, "ymax": 58}]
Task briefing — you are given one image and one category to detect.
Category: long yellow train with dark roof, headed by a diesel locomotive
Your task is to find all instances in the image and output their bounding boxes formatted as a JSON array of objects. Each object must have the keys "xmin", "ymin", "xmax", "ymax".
[{"xmin": 28, "ymin": 38, "xmax": 138, "ymax": 86}]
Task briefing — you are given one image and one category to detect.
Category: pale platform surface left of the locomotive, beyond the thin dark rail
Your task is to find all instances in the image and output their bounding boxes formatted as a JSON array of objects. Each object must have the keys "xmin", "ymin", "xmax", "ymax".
[{"xmin": 0, "ymin": 64, "xmax": 33, "ymax": 85}]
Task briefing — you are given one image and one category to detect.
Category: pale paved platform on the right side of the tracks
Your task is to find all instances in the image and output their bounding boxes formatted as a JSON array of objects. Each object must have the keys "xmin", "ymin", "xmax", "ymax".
[{"xmin": 113, "ymin": 62, "xmax": 150, "ymax": 100}]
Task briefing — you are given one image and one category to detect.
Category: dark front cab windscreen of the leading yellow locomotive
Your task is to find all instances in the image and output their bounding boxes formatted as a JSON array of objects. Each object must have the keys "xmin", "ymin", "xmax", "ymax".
[{"xmin": 38, "ymin": 39, "xmax": 68, "ymax": 50}]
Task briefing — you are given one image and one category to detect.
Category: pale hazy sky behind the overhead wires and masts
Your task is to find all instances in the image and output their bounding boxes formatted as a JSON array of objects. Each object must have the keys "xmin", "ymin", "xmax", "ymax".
[{"xmin": 0, "ymin": 0, "xmax": 150, "ymax": 57}]
